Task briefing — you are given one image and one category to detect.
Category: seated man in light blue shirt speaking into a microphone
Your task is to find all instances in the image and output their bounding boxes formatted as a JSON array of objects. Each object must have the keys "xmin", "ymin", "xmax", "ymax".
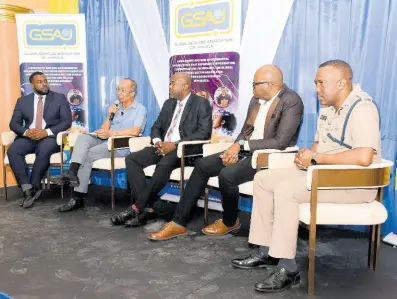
[{"xmin": 51, "ymin": 78, "xmax": 146, "ymax": 212}]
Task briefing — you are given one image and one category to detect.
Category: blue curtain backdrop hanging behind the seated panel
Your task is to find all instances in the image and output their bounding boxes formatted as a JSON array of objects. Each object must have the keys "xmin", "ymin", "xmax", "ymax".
[{"xmin": 79, "ymin": 0, "xmax": 397, "ymax": 233}]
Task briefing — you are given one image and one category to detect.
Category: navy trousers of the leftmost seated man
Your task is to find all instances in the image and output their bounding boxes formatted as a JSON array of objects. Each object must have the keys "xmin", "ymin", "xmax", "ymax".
[{"xmin": 7, "ymin": 137, "xmax": 59, "ymax": 188}]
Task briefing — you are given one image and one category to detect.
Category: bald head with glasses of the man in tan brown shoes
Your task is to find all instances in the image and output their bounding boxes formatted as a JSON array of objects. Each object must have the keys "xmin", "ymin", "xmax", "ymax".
[{"xmin": 253, "ymin": 64, "xmax": 283, "ymax": 100}]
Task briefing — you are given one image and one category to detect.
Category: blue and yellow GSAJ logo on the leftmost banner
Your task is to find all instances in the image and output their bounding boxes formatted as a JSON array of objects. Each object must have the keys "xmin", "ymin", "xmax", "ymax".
[{"xmin": 25, "ymin": 23, "xmax": 77, "ymax": 47}]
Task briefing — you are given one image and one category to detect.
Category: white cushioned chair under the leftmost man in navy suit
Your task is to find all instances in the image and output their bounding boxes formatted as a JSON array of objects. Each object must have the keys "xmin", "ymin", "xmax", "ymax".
[{"xmin": 1, "ymin": 131, "xmax": 68, "ymax": 200}]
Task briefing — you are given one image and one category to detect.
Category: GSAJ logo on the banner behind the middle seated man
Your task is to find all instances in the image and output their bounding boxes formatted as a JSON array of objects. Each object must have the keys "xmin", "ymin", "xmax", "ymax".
[{"xmin": 175, "ymin": 1, "xmax": 230, "ymax": 38}]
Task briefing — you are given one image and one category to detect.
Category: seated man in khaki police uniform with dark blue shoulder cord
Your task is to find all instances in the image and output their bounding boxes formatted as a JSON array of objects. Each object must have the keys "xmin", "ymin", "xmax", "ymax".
[{"xmin": 232, "ymin": 60, "xmax": 381, "ymax": 292}]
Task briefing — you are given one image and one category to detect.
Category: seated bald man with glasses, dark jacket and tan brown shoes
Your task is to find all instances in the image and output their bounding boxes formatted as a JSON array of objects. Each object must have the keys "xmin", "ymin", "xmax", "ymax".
[{"xmin": 149, "ymin": 65, "xmax": 303, "ymax": 241}]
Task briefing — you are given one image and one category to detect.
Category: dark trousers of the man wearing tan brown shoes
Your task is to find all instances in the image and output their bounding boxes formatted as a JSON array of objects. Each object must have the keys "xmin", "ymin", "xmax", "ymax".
[{"xmin": 173, "ymin": 153, "xmax": 255, "ymax": 226}]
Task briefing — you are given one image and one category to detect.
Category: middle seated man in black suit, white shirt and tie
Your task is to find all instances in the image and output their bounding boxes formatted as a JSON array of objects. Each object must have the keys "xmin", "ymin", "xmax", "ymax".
[{"xmin": 111, "ymin": 73, "xmax": 211, "ymax": 226}]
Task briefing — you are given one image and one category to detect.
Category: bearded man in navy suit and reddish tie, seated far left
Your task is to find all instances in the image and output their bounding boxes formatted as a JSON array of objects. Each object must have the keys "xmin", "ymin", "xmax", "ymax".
[{"xmin": 7, "ymin": 72, "xmax": 72, "ymax": 208}]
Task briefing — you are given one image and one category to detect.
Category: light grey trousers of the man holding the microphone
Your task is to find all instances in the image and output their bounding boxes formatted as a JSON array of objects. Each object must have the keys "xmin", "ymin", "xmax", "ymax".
[{"xmin": 70, "ymin": 134, "xmax": 110, "ymax": 193}]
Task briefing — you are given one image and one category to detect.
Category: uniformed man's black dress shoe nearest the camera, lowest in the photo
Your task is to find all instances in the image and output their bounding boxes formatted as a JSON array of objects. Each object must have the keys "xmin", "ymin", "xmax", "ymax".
[{"xmin": 254, "ymin": 268, "xmax": 301, "ymax": 293}]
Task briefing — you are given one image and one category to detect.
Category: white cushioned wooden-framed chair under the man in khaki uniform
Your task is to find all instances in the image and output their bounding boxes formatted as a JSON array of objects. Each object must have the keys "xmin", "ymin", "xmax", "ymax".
[{"xmin": 268, "ymin": 153, "xmax": 393, "ymax": 295}]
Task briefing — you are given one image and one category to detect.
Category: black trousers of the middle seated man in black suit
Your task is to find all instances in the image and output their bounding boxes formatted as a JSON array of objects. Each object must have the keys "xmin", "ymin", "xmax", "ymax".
[{"xmin": 125, "ymin": 147, "xmax": 181, "ymax": 212}]
